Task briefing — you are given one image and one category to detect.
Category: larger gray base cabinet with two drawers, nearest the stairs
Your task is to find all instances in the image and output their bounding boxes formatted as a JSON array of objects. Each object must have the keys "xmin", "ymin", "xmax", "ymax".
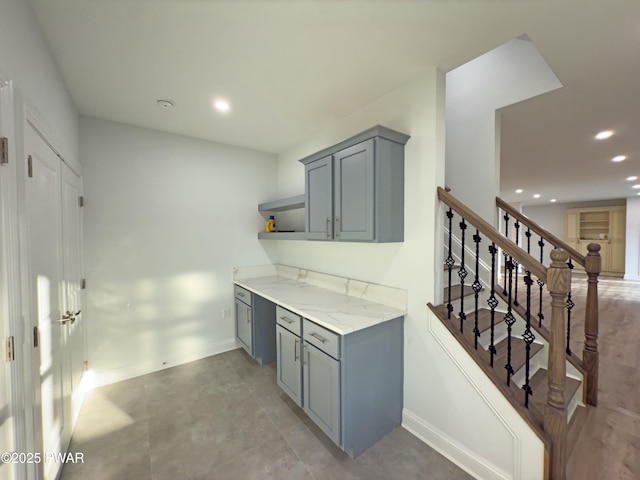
[{"xmin": 277, "ymin": 307, "xmax": 404, "ymax": 457}]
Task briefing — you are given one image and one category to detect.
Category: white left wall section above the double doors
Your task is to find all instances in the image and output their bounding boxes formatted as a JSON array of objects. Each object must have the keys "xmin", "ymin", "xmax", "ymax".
[{"xmin": 0, "ymin": 0, "xmax": 78, "ymax": 160}]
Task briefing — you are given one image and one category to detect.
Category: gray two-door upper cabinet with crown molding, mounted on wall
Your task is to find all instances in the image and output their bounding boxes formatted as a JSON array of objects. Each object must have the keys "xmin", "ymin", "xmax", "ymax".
[{"xmin": 300, "ymin": 126, "xmax": 409, "ymax": 242}]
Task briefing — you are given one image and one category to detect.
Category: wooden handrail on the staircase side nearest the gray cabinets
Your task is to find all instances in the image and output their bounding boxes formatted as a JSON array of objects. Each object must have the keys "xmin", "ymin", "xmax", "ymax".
[{"xmin": 438, "ymin": 187, "xmax": 547, "ymax": 282}]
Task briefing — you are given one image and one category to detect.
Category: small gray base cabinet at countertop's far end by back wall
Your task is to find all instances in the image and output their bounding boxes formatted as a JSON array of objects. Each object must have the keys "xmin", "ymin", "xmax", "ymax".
[{"xmin": 234, "ymin": 285, "xmax": 276, "ymax": 365}]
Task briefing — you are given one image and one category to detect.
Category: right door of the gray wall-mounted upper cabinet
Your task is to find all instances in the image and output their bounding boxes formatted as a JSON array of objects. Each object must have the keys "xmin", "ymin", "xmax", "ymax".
[{"xmin": 333, "ymin": 139, "xmax": 375, "ymax": 241}]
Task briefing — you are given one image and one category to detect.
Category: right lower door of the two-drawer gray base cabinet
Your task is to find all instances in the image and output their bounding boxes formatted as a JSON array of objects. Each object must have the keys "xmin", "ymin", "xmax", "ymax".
[{"xmin": 303, "ymin": 343, "xmax": 342, "ymax": 446}]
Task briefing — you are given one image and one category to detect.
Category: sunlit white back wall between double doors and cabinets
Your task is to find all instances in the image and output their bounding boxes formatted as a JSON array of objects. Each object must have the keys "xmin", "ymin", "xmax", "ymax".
[{"xmin": 81, "ymin": 117, "xmax": 276, "ymax": 383}]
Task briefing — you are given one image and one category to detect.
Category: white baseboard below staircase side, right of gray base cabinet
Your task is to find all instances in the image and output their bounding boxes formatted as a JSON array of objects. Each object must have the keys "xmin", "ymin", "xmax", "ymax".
[{"xmin": 402, "ymin": 408, "xmax": 511, "ymax": 480}]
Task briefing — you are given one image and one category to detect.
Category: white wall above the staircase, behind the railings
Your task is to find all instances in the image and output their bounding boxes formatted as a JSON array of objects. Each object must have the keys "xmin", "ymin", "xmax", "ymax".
[{"xmin": 445, "ymin": 39, "xmax": 561, "ymax": 224}]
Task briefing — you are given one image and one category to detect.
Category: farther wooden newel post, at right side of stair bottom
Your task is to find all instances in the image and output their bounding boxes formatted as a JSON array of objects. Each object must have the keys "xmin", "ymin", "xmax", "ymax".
[{"xmin": 582, "ymin": 243, "xmax": 602, "ymax": 406}]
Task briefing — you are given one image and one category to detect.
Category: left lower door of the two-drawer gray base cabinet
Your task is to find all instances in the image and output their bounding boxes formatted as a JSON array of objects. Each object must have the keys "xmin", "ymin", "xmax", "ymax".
[{"xmin": 276, "ymin": 325, "xmax": 302, "ymax": 407}]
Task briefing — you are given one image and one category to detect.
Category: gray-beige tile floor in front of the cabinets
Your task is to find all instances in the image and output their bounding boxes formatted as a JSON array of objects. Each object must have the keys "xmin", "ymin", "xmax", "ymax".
[{"xmin": 61, "ymin": 350, "xmax": 472, "ymax": 480}]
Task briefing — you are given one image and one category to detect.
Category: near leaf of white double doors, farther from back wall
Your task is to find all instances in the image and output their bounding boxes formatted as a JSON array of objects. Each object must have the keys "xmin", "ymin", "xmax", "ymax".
[{"xmin": 25, "ymin": 125, "xmax": 70, "ymax": 480}]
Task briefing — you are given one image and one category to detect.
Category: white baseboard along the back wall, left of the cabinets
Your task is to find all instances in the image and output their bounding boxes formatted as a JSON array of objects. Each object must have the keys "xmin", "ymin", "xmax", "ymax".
[{"xmin": 84, "ymin": 338, "xmax": 238, "ymax": 389}]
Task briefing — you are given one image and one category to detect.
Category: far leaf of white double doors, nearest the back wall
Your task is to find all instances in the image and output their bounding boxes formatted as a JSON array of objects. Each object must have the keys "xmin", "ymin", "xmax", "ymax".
[{"xmin": 62, "ymin": 163, "xmax": 87, "ymax": 423}]
